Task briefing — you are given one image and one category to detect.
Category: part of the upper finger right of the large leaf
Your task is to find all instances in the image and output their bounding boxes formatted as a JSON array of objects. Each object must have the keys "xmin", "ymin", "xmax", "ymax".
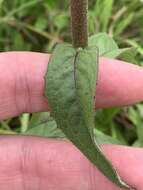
[{"xmin": 96, "ymin": 58, "xmax": 143, "ymax": 108}]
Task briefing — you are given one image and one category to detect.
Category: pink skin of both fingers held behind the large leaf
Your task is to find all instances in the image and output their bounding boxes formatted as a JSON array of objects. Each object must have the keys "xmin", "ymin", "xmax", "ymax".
[{"xmin": 0, "ymin": 52, "xmax": 143, "ymax": 190}]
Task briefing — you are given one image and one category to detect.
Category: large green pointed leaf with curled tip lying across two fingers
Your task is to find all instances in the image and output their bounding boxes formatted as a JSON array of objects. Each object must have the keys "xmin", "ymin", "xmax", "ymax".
[{"xmin": 45, "ymin": 44, "xmax": 129, "ymax": 189}]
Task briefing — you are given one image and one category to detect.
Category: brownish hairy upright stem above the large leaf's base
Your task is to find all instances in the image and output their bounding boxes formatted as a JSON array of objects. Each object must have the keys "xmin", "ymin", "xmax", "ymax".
[{"xmin": 71, "ymin": 0, "xmax": 88, "ymax": 48}]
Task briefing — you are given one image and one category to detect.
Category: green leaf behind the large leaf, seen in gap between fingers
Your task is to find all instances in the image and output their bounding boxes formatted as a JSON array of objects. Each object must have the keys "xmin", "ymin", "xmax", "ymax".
[{"xmin": 23, "ymin": 112, "xmax": 122, "ymax": 145}]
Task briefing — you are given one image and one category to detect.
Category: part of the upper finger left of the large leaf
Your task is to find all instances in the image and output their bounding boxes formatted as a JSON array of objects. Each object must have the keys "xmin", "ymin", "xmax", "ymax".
[{"xmin": 0, "ymin": 52, "xmax": 49, "ymax": 119}]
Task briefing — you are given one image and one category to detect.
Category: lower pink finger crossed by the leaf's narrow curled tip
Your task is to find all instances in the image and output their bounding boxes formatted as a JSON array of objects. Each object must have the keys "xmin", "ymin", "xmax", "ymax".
[{"xmin": 0, "ymin": 137, "xmax": 143, "ymax": 190}]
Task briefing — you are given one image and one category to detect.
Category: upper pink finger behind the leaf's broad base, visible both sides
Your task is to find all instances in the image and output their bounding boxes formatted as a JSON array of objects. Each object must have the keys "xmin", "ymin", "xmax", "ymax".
[{"xmin": 0, "ymin": 52, "xmax": 143, "ymax": 119}]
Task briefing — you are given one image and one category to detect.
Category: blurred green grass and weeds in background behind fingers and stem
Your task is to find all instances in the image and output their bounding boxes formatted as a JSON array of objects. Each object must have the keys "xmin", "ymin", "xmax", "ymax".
[{"xmin": 0, "ymin": 0, "xmax": 143, "ymax": 146}]
